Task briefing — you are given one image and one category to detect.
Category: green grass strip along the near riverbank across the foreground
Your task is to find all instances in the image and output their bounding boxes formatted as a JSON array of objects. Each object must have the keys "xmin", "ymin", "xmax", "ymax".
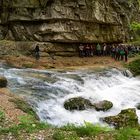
[{"xmin": 0, "ymin": 112, "xmax": 140, "ymax": 140}]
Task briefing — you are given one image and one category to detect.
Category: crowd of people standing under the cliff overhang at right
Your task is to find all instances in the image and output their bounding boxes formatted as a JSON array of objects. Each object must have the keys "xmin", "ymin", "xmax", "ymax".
[{"xmin": 79, "ymin": 43, "xmax": 140, "ymax": 61}]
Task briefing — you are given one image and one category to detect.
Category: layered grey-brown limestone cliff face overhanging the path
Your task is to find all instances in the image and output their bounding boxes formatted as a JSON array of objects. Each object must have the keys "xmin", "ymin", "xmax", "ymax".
[{"xmin": 0, "ymin": 0, "xmax": 139, "ymax": 43}]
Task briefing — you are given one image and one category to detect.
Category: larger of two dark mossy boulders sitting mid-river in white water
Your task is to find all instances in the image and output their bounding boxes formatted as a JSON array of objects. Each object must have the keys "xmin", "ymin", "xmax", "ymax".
[{"xmin": 64, "ymin": 97, "xmax": 94, "ymax": 111}]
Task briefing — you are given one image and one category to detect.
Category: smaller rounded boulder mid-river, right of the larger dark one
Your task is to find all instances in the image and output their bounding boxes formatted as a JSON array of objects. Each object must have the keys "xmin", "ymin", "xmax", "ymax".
[{"xmin": 94, "ymin": 100, "xmax": 113, "ymax": 111}]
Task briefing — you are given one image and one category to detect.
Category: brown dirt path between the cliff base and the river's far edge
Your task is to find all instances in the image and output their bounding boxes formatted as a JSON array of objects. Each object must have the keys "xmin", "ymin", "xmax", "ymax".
[{"xmin": 3, "ymin": 56, "xmax": 124, "ymax": 69}]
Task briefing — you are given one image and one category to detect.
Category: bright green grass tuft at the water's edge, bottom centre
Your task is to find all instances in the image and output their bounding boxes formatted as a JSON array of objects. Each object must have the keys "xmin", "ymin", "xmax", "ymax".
[{"xmin": 61, "ymin": 122, "xmax": 111, "ymax": 137}]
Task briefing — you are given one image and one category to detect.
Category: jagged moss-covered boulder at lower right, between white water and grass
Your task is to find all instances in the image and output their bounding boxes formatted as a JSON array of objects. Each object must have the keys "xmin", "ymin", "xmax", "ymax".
[{"xmin": 102, "ymin": 108, "xmax": 138, "ymax": 128}]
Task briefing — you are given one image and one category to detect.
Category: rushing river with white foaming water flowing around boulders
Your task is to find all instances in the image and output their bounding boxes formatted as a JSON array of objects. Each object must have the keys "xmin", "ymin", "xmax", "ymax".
[{"xmin": 0, "ymin": 68, "xmax": 140, "ymax": 126}]
